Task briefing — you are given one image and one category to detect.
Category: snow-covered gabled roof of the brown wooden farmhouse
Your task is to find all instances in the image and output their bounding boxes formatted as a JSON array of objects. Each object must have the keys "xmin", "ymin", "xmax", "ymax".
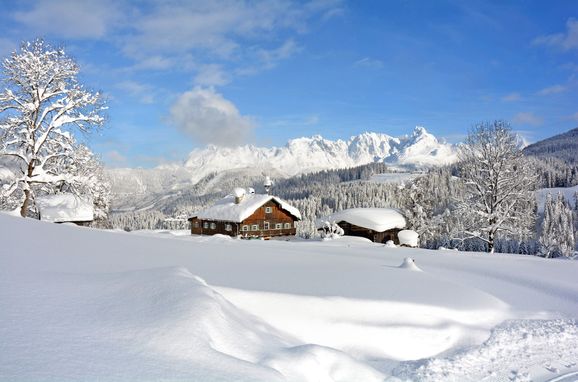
[{"xmin": 193, "ymin": 194, "xmax": 301, "ymax": 223}]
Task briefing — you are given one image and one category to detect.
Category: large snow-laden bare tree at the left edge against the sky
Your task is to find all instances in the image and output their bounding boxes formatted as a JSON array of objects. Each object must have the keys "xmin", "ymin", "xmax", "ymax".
[{"xmin": 0, "ymin": 40, "xmax": 105, "ymax": 216}]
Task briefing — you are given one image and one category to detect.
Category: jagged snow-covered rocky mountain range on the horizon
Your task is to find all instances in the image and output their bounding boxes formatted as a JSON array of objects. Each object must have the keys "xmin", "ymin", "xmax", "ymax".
[{"xmin": 185, "ymin": 126, "xmax": 456, "ymax": 183}]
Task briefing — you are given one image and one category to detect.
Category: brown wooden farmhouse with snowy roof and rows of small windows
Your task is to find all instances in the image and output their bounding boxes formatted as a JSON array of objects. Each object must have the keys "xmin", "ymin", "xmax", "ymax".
[{"xmin": 189, "ymin": 189, "xmax": 301, "ymax": 238}]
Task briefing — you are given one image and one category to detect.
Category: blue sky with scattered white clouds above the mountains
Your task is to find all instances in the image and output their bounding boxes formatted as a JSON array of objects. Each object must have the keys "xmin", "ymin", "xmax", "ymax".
[{"xmin": 0, "ymin": 0, "xmax": 578, "ymax": 167}]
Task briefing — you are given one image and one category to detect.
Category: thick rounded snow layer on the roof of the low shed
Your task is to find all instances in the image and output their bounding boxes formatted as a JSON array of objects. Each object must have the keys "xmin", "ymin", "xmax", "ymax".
[{"xmin": 317, "ymin": 208, "xmax": 406, "ymax": 232}]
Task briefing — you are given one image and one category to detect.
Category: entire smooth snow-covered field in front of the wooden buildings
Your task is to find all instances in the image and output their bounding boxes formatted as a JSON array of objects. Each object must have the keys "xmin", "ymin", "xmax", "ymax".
[{"xmin": 0, "ymin": 214, "xmax": 578, "ymax": 382}]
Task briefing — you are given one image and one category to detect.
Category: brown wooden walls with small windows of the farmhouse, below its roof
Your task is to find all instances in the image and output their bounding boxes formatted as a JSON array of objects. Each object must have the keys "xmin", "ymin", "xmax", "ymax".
[{"xmin": 189, "ymin": 200, "xmax": 298, "ymax": 238}]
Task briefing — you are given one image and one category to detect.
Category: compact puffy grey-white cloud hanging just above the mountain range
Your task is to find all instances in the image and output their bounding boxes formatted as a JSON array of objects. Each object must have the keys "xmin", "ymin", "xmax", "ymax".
[{"xmin": 170, "ymin": 87, "xmax": 255, "ymax": 146}]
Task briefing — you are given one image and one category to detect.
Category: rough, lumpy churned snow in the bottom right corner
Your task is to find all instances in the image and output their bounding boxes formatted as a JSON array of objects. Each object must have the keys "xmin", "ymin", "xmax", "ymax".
[{"xmin": 394, "ymin": 319, "xmax": 578, "ymax": 382}]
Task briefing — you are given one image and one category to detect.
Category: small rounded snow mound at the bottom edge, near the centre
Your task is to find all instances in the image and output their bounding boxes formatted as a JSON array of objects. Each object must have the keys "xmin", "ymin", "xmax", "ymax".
[{"xmin": 263, "ymin": 345, "xmax": 384, "ymax": 382}]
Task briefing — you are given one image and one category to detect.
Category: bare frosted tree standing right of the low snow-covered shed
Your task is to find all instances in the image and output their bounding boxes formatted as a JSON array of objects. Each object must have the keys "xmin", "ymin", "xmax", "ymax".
[{"xmin": 458, "ymin": 121, "xmax": 537, "ymax": 253}]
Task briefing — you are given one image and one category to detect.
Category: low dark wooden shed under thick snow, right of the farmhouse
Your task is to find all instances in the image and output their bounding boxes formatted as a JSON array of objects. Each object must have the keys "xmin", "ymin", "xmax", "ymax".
[{"xmin": 317, "ymin": 208, "xmax": 407, "ymax": 244}]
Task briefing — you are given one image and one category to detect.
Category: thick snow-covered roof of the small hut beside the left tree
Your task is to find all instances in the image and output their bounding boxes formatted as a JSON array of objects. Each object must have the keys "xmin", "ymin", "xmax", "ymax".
[{"xmin": 36, "ymin": 194, "xmax": 94, "ymax": 223}]
